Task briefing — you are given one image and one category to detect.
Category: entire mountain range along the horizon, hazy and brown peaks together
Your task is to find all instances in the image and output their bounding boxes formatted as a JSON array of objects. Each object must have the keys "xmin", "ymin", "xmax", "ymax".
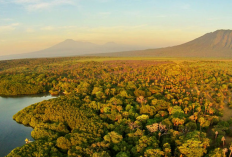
[{"xmin": 0, "ymin": 30, "xmax": 232, "ymax": 60}]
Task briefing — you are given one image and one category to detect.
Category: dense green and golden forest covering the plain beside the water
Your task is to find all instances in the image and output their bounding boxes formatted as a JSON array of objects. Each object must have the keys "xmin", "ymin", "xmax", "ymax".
[{"xmin": 0, "ymin": 57, "xmax": 232, "ymax": 157}]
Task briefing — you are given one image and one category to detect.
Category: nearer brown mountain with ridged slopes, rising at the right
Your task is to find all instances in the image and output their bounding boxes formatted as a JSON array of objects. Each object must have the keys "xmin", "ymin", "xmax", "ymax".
[{"xmin": 94, "ymin": 30, "xmax": 232, "ymax": 58}]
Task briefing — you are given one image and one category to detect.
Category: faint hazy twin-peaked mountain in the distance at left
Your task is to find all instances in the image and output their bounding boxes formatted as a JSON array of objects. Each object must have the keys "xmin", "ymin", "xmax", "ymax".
[{"xmin": 0, "ymin": 39, "xmax": 149, "ymax": 60}]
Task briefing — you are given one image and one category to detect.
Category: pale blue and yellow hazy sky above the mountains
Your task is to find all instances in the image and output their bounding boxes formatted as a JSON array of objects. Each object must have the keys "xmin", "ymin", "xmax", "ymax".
[{"xmin": 0, "ymin": 0, "xmax": 232, "ymax": 55}]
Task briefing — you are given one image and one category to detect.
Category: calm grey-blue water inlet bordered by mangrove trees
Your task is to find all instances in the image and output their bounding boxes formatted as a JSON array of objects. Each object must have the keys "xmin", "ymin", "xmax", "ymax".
[{"xmin": 0, "ymin": 95, "xmax": 54, "ymax": 157}]
